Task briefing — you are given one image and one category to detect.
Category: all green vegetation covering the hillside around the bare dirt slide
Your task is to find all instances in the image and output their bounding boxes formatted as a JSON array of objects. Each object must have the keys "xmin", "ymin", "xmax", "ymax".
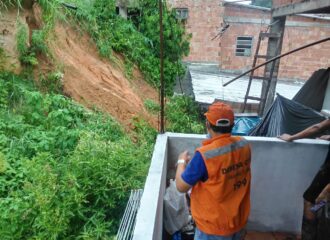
[{"xmin": 0, "ymin": 0, "xmax": 204, "ymax": 240}]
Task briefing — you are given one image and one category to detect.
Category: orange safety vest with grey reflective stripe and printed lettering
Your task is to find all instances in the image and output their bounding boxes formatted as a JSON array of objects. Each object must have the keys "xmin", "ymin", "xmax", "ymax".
[{"xmin": 191, "ymin": 134, "xmax": 251, "ymax": 236}]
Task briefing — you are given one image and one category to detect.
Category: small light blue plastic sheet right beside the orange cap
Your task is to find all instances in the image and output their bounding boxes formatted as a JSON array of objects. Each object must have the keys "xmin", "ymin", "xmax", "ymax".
[{"xmin": 232, "ymin": 116, "xmax": 260, "ymax": 136}]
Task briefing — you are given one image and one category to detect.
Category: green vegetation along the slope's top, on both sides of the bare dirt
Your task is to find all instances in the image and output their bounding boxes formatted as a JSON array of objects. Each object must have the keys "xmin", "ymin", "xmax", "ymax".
[{"xmin": 12, "ymin": 0, "xmax": 190, "ymax": 95}]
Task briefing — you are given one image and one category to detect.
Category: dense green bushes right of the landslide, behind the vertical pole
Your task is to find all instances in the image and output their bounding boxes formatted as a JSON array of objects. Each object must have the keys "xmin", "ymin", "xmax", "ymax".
[{"xmin": 72, "ymin": 0, "xmax": 190, "ymax": 94}]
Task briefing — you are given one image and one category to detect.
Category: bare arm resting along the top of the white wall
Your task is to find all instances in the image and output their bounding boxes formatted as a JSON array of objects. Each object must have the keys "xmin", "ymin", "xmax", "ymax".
[{"xmin": 278, "ymin": 119, "xmax": 330, "ymax": 142}]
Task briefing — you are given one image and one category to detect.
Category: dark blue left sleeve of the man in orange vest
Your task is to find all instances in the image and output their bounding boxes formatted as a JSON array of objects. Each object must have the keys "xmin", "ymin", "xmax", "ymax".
[{"xmin": 181, "ymin": 152, "xmax": 208, "ymax": 186}]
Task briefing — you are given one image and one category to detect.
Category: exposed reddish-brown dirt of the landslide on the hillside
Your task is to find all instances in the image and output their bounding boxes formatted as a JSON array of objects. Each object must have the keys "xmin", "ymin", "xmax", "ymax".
[{"xmin": 0, "ymin": 5, "xmax": 157, "ymax": 127}]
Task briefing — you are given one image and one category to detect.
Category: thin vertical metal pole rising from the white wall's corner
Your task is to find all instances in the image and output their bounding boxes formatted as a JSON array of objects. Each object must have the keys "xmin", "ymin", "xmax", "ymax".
[{"xmin": 159, "ymin": 0, "xmax": 165, "ymax": 133}]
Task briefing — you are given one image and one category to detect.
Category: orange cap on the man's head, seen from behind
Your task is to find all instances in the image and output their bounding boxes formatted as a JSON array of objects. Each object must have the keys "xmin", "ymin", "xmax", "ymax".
[{"xmin": 204, "ymin": 102, "xmax": 234, "ymax": 127}]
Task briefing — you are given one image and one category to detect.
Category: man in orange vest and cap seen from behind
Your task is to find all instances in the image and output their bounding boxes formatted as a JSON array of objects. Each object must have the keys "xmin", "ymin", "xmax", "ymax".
[{"xmin": 175, "ymin": 102, "xmax": 251, "ymax": 240}]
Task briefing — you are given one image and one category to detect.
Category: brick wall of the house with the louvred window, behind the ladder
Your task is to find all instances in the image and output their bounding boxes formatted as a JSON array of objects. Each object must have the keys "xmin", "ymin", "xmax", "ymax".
[{"xmin": 219, "ymin": 6, "xmax": 330, "ymax": 80}]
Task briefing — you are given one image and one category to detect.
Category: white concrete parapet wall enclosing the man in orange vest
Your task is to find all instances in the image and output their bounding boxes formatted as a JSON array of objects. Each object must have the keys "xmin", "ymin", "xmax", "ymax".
[{"xmin": 133, "ymin": 133, "xmax": 329, "ymax": 240}]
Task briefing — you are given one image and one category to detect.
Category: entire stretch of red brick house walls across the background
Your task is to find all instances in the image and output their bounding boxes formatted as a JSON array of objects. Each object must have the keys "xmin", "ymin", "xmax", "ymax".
[{"xmin": 169, "ymin": 0, "xmax": 330, "ymax": 80}]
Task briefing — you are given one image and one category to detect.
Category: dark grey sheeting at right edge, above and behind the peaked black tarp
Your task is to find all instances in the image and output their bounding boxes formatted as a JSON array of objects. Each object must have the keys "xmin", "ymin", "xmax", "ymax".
[{"xmin": 292, "ymin": 68, "xmax": 330, "ymax": 111}]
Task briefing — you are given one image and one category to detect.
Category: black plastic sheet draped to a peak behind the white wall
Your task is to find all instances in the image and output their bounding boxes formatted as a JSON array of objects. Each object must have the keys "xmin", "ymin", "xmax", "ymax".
[{"xmin": 250, "ymin": 94, "xmax": 325, "ymax": 137}]
